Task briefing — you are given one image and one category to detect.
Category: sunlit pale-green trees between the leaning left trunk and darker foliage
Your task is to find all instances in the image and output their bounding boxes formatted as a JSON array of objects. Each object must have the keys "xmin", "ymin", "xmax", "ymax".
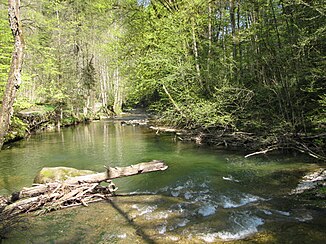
[{"xmin": 9, "ymin": 0, "xmax": 127, "ymax": 116}]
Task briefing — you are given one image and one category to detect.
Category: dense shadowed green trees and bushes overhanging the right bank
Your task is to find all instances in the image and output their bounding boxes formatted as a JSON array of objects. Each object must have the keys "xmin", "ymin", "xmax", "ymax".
[{"xmin": 123, "ymin": 0, "xmax": 326, "ymax": 133}]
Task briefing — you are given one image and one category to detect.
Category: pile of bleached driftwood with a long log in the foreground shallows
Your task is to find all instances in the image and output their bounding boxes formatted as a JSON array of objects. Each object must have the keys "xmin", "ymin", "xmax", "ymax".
[{"xmin": 0, "ymin": 160, "xmax": 168, "ymax": 216}]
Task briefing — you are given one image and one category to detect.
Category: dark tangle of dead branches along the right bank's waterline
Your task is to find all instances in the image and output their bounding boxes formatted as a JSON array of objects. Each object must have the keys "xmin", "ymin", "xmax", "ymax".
[{"xmin": 149, "ymin": 126, "xmax": 326, "ymax": 161}]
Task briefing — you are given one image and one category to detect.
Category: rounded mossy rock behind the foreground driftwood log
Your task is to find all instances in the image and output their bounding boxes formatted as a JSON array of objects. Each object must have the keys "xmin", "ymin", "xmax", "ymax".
[{"xmin": 34, "ymin": 167, "xmax": 96, "ymax": 184}]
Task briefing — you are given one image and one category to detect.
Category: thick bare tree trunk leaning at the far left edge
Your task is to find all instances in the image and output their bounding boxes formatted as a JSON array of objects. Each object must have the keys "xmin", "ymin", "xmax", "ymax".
[{"xmin": 0, "ymin": 0, "xmax": 24, "ymax": 150}]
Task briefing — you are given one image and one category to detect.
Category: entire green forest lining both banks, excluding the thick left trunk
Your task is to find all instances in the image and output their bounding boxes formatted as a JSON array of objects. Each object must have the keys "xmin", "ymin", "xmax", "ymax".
[{"xmin": 0, "ymin": 0, "xmax": 326, "ymax": 159}]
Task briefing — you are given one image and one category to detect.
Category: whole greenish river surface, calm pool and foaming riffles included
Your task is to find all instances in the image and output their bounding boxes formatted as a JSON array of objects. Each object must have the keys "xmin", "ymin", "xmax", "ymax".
[{"xmin": 0, "ymin": 121, "xmax": 326, "ymax": 243}]
